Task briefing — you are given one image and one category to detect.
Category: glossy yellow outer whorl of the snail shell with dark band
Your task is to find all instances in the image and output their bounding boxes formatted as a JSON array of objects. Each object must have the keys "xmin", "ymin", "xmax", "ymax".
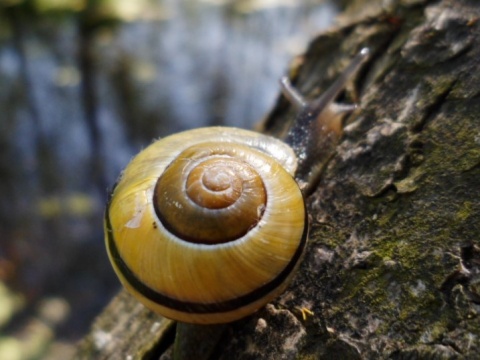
[{"xmin": 105, "ymin": 127, "xmax": 308, "ymax": 324}]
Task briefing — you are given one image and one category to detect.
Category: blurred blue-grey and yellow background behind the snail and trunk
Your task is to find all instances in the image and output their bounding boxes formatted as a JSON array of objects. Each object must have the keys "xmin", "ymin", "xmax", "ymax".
[{"xmin": 0, "ymin": 0, "xmax": 340, "ymax": 360}]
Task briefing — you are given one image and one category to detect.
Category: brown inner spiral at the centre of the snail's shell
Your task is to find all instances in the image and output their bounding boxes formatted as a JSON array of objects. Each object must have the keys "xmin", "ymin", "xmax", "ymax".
[{"xmin": 154, "ymin": 142, "xmax": 267, "ymax": 244}]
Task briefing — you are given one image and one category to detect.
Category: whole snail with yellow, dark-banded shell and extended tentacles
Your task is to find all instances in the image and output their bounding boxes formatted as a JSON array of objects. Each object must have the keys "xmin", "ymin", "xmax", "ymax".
[{"xmin": 104, "ymin": 49, "xmax": 368, "ymax": 324}]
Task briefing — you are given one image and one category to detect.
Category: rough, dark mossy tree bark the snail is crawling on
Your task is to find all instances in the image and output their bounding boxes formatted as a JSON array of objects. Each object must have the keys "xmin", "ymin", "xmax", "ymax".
[{"xmin": 78, "ymin": 0, "xmax": 480, "ymax": 359}]
